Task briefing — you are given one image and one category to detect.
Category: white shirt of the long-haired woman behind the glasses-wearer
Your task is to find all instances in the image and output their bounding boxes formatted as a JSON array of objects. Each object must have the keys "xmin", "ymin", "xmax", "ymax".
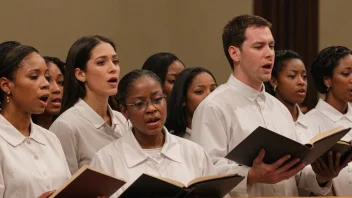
[{"xmin": 49, "ymin": 99, "xmax": 128, "ymax": 174}]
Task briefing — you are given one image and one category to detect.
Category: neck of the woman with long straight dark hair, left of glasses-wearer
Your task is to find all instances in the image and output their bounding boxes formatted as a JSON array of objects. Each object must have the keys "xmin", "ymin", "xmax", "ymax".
[{"xmin": 83, "ymin": 92, "xmax": 110, "ymax": 122}]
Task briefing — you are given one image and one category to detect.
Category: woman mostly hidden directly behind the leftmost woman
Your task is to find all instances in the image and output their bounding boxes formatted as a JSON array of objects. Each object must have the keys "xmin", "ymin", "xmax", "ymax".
[{"xmin": 32, "ymin": 56, "xmax": 65, "ymax": 129}]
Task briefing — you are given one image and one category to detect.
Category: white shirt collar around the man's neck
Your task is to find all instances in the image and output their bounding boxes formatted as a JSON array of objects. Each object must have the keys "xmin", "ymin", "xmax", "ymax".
[{"xmin": 227, "ymin": 74, "xmax": 265, "ymax": 102}]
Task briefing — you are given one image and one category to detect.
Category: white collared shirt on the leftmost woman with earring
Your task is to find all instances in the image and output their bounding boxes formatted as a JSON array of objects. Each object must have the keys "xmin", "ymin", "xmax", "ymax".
[{"xmin": 0, "ymin": 115, "xmax": 71, "ymax": 198}]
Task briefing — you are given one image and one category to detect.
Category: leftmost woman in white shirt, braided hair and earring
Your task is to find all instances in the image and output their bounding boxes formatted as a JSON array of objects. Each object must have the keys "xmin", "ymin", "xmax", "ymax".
[{"xmin": 0, "ymin": 41, "xmax": 70, "ymax": 198}]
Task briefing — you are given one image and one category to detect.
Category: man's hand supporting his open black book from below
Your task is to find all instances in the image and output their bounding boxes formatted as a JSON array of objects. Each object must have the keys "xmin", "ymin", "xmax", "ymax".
[{"xmin": 247, "ymin": 149, "xmax": 305, "ymax": 184}]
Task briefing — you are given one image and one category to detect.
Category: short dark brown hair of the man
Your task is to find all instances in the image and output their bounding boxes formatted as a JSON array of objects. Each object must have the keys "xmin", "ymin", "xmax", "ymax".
[{"xmin": 222, "ymin": 15, "xmax": 271, "ymax": 70}]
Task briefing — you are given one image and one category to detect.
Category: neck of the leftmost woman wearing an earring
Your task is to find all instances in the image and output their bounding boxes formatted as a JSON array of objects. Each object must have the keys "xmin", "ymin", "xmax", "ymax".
[{"xmin": 1, "ymin": 104, "xmax": 31, "ymax": 137}]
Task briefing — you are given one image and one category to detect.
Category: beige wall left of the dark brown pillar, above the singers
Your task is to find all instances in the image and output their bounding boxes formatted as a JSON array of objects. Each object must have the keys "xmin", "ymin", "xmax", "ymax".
[{"xmin": 0, "ymin": 0, "xmax": 253, "ymax": 83}]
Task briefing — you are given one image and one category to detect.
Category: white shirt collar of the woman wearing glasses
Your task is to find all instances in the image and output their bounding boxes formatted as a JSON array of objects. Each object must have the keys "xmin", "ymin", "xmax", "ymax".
[{"xmin": 121, "ymin": 127, "xmax": 182, "ymax": 168}]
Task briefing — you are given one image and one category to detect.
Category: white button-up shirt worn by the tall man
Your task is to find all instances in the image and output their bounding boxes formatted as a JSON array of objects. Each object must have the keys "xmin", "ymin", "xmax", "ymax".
[{"xmin": 191, "ymin": 75, "xmax": 331, "ymax": 196}]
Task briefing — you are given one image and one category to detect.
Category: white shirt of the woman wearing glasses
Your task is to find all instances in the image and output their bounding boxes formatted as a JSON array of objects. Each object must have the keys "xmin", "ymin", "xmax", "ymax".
[{"xmin": 90, "ymin": 127, "xmax": 216, "ymax": 197}]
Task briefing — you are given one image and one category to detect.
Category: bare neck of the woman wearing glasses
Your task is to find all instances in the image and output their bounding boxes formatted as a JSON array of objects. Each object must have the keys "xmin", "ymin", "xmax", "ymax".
[{"xmin": 133, "ymin": 130, "xmax": 165, "ymax": 149}]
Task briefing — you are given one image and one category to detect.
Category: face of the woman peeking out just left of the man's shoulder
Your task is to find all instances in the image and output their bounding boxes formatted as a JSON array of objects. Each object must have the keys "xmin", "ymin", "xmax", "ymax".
[{"xmin": 184, "ymin": 72, "xmax": 216, "ymax": 117}]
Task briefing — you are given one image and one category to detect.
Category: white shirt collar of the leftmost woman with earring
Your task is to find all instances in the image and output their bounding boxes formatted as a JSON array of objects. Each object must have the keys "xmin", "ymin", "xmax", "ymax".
[{"xmin": 0, "ymin": 115, "xmax": 45, "ymax": 147}]
